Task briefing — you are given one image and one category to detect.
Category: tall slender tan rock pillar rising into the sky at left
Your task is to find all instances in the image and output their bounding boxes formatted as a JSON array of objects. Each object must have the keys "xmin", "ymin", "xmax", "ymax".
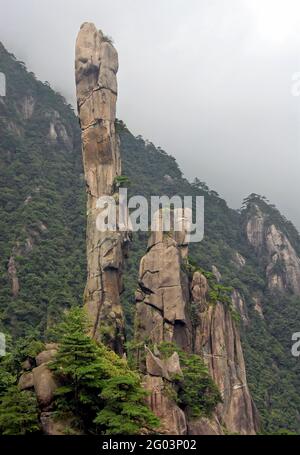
[{"xmin": 75, "ymin": 23, "xmax": 126, "ymax": 354}]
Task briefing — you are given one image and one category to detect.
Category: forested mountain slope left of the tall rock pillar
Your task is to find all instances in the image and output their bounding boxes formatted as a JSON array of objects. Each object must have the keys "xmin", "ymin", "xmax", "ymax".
[{"xmin": 0, "ymin": 41, "xmax": 85, "ymax": 336}]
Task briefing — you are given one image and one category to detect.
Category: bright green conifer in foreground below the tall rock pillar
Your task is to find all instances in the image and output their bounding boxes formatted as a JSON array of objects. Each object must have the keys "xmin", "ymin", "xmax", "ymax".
[{"xmin": 50, "ymin": 308, "xmax": 158, "ymax": 434}]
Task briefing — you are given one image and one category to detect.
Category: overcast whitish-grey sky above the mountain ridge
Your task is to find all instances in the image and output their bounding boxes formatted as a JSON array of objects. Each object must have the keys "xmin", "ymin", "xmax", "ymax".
[{"xmin": 0, "ymin": 0, "xmax": 300, "ymax": 228}]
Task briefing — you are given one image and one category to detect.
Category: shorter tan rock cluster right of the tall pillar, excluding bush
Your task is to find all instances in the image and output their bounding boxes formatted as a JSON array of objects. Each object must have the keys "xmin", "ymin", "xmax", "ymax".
[{"xmin": 135, "ymin": 213, "xmax": 258, "ymax": 435}]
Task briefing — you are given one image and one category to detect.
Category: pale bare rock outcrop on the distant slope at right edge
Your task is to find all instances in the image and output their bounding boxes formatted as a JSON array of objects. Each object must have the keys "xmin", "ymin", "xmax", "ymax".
[{"xmin": 246, "ymin": 204, "xmax": 300, "ymax": 295}]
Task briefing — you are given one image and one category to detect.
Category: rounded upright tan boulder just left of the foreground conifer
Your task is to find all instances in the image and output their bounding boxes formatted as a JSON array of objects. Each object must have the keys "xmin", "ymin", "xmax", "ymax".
[{"xmin": 32, "ymin": 364, "xmax": 57, "ymax": 409}]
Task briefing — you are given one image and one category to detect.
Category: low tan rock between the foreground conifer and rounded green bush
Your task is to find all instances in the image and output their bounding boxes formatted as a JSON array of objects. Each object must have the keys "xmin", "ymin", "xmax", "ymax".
[{"xmin": 144, "ymin": 375, "xmax": 187, "ymax": 435}]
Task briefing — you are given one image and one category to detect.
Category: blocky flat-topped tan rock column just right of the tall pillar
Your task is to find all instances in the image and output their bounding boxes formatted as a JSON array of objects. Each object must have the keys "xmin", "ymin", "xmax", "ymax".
[{"xmin": 135, "ymin": 228, "xmax": 192, "ymax": 351}]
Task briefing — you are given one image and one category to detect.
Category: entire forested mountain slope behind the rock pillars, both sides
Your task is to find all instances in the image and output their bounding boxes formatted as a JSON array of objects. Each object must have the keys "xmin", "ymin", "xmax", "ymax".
[{"xmin": 0, "ymin": 41, "xmax": 300, "ymax": 433}]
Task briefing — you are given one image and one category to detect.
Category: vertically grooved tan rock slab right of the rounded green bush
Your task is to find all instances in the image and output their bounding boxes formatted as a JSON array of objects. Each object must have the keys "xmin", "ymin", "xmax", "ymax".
[{"xmin": 195, "ymin": 303, "xmax": 259, "ymax": 435}]
